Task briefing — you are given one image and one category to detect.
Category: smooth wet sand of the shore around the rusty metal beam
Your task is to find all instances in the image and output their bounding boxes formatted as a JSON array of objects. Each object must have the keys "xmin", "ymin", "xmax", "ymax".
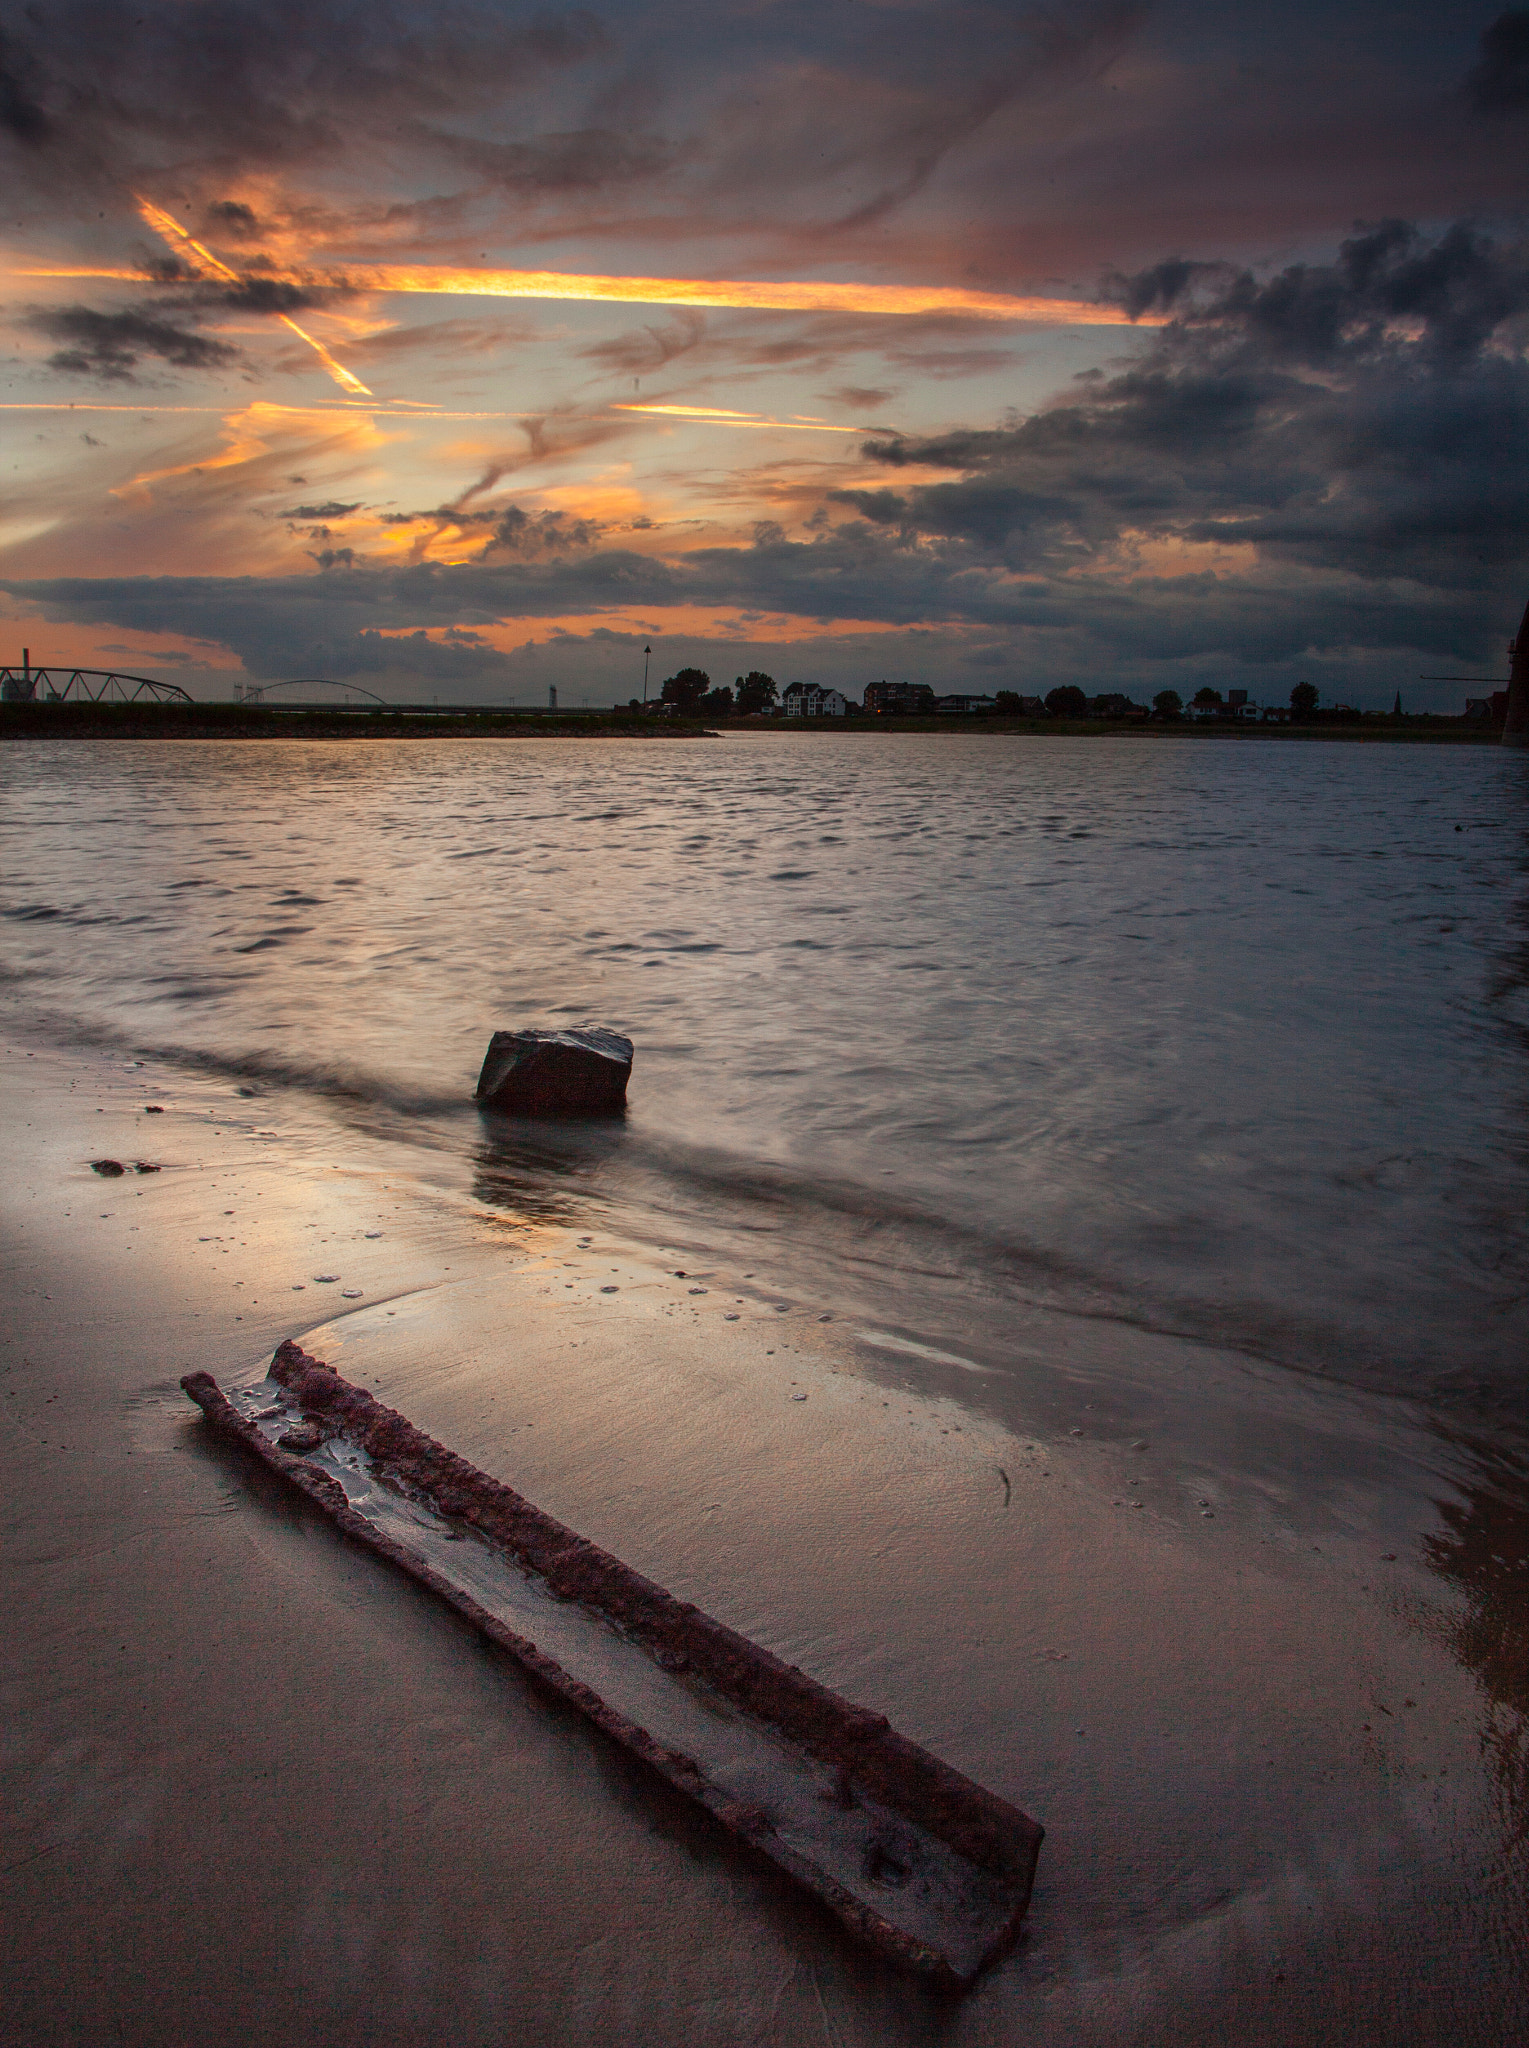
[{"xmin": 0, "ymin": 1044, "xmax": 1529, "ymax": 2048}]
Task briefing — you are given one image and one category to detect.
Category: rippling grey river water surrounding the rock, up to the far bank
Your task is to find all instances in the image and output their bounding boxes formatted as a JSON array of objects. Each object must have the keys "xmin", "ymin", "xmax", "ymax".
[{"xmin": 0, "ymin": 735, "xmax": 1529, "ymax": 1405}]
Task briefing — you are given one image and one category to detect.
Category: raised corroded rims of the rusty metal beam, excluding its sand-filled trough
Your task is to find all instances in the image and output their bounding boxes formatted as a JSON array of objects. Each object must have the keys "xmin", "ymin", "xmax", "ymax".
[{"xmin": 180, "ymin": 1341, "xmax": 1044, "ymax": 1991}]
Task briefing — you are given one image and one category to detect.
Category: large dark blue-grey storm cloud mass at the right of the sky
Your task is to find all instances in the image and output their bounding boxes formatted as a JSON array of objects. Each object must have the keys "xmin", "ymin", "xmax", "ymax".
[{"xmin": 837, "ymin": 221, "xmax": 1529, "ymax": 590}]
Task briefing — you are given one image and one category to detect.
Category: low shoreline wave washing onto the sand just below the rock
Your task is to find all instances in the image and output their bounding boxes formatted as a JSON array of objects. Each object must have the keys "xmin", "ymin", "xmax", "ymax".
[{"xmin": 8, "ymin": 987, "xmax": 1521, "ymax": 1411}]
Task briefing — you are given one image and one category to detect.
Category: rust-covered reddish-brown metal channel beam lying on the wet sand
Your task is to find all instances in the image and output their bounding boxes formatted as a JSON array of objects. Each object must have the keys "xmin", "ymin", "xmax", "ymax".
[{"xmin": 180, "ymin": 1341, "xmax": 1044, "ymax": 1989}]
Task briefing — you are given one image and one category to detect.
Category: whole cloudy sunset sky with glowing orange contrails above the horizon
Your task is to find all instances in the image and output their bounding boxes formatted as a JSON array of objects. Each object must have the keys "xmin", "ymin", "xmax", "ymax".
[{"xmin": 0, "ymin": 0, "xmax": 1529, "ymax": 709}]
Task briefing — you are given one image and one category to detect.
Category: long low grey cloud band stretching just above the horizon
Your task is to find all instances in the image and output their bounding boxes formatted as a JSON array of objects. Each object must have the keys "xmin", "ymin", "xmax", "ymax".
[{"xmin": 0, "ymin": 507, "xmax": 1506, "ymax": 676}]
